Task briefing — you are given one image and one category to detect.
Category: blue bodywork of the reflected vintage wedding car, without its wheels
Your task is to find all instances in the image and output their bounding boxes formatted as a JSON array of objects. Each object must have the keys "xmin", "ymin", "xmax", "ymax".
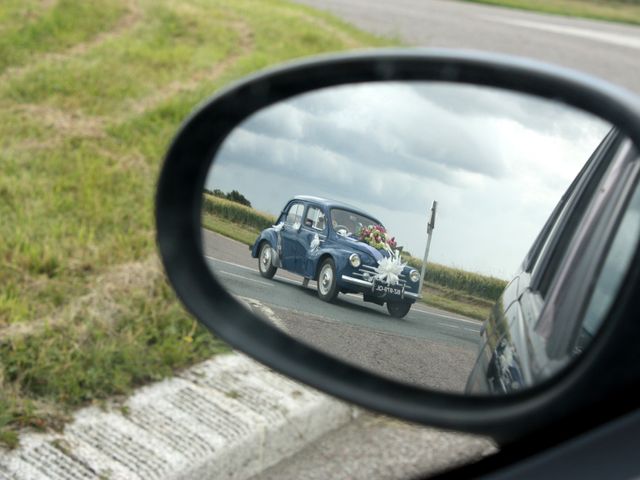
[{"xmin": 251, "ymin": 196, "xmax": 419, "ymax": 316}]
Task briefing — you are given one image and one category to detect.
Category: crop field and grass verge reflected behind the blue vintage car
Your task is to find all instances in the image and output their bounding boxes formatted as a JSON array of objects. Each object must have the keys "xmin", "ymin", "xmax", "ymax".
[{"xmin": 202, "ymin": 203, "xmax": 506, "ymax": 320}]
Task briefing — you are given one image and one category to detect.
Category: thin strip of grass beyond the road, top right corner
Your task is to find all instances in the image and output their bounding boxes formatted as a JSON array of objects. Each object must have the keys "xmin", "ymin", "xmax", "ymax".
[{"xmin": 464, "ymin": 0, "xmax": 640, "ymax": 25}]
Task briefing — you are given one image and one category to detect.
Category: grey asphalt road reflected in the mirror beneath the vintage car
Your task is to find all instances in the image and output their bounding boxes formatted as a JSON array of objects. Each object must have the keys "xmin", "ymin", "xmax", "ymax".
[{"xmin": 203, "ymin": 230, "xmax": 480, "ymax": 391}]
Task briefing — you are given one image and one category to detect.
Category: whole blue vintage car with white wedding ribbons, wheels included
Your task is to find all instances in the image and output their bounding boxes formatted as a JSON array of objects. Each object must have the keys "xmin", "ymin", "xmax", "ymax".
[{"xmin": 251, "ymin": 196, "xmax": 420, "ymax": 318}]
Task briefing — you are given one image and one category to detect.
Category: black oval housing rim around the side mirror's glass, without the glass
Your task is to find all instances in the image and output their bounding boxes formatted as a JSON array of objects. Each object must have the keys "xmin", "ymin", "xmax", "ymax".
[{"xmin": 156, "ymin": 50, "xmax": 640, "ymax": 443}]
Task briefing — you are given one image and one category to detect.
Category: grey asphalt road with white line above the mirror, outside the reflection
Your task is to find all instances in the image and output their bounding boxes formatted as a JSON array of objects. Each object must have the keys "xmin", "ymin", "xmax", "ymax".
[{"xmin": 296, "ymin": 0, "xmax": 640, "ymax": 92}]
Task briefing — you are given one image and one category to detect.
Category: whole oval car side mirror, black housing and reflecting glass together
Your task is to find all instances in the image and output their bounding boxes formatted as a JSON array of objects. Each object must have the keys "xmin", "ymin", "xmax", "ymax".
[{"xmin": 156, "ymin": 50, "xmax": 640, "ymax": 441}]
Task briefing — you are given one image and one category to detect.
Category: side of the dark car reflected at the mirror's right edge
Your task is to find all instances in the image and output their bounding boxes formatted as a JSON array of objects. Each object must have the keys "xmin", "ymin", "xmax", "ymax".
[{"xmin": 466, "ymin": 130, "xmax": 640, "ymax": 394}]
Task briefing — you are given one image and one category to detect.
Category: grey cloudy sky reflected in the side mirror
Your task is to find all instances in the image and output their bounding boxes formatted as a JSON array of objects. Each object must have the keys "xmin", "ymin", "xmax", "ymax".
[{"xmin": 206, "ymin": 82, "xmax": 610, "ymax": 279}]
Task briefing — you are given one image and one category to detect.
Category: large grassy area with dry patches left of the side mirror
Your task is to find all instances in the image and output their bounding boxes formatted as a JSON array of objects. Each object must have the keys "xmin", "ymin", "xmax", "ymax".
[{"xmin": 0, "ymin": 0, "xmax": 396, "ymax": 447}]
